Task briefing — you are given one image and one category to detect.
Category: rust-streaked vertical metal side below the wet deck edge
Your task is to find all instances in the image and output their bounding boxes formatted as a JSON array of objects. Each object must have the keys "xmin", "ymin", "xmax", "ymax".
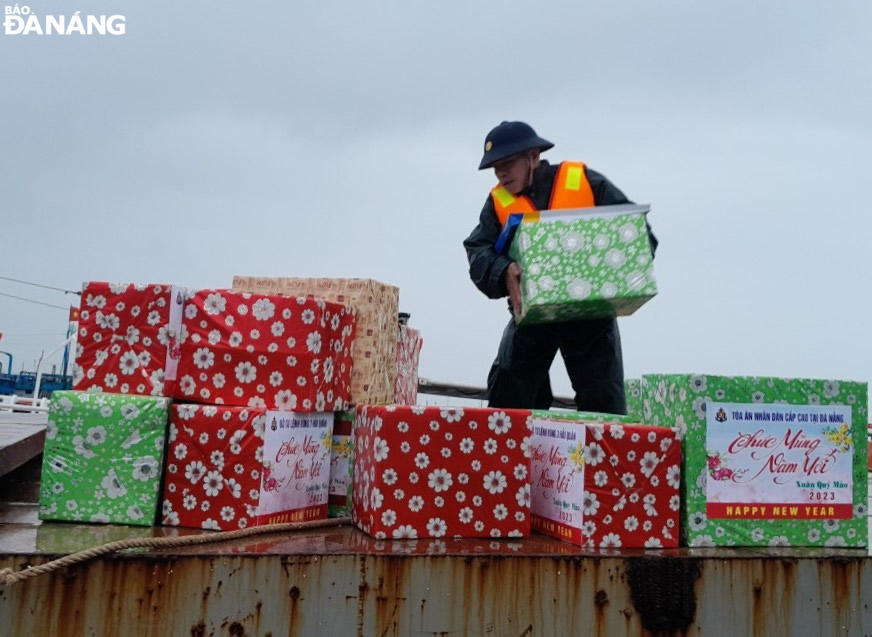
[{"xmin": 0, "ymin": 538, "xmax": 872, "ymax": 636}]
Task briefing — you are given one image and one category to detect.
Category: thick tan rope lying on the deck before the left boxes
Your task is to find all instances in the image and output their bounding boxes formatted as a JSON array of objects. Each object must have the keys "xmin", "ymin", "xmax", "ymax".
[{"xmin": 0, "ymin": 518, "xmax": 351, "ymax": 586}]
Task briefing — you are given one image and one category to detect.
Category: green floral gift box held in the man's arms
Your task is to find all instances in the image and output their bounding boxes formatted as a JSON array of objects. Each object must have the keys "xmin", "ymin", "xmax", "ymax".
[{"xmin": 509, "ymin": 206, "xmax": 657, "ymax": 325}]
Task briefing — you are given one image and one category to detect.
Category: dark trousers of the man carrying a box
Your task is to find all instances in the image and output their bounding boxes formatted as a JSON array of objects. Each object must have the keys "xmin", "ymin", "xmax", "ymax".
[{"xmin": 487, "ymin": 319, "xmax": 627, "ymax": 414}]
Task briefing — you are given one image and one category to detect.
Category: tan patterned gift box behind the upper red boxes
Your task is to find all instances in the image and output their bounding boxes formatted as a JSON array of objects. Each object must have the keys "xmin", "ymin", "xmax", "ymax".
[{"xmin": 233, "ymin": 276, "xmax": 400, "ymax": 405}]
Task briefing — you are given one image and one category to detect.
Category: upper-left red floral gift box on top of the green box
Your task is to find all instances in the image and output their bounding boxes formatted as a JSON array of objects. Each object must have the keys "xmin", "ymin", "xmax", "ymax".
[{"xmin": 73, "ymin": 281, "xmax": 186, "ymax": 396}]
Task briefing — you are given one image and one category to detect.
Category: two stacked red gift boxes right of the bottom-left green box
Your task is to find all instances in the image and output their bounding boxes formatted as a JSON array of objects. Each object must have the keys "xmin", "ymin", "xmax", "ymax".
[{"xmin": 163, "ymin": 290, "xmax": 355, "ymax": 530}]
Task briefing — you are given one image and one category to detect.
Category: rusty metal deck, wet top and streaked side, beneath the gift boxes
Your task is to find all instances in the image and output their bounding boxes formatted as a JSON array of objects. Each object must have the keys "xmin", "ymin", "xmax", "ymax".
[{"xmin": 0, "ymin": 505, "xmax": 872, "ymax": 637}]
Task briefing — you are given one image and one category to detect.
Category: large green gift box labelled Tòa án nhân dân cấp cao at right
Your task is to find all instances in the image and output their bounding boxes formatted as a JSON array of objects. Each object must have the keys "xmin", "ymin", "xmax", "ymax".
[{"xmin": 641, "ymin": 374, "xmax": 868, "ymax": 547}]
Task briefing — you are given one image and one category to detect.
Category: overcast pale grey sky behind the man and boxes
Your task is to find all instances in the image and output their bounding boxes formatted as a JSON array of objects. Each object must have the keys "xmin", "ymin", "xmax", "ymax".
[{"xmin": 0, "ymin": 0, "xmax": 872, "ymax": 402}]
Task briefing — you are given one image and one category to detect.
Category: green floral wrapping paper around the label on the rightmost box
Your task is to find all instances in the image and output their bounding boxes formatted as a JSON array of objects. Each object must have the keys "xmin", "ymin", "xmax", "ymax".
[{"xmin": 641, "ymin": 374, "xmax": 868, "ymax": 546}]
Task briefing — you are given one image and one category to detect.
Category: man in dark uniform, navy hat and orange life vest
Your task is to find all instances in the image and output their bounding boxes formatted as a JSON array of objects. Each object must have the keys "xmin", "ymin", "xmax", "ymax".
[{"xmin": 463, "ymin": 122, "xmax": 657, "ymax": 414}]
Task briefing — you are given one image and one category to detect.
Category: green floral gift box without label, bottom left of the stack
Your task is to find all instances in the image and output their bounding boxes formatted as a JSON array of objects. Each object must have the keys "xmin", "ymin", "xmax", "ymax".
[{"xmin": 39, "ymin": 391, "xmax": 169, "ymax": 526}]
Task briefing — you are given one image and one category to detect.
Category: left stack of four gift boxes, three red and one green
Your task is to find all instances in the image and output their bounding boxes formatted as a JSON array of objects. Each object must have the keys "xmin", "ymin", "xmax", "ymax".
[{"xmin": 41, "ymin": 283, "xmax": 355, "ymax": 529}]
